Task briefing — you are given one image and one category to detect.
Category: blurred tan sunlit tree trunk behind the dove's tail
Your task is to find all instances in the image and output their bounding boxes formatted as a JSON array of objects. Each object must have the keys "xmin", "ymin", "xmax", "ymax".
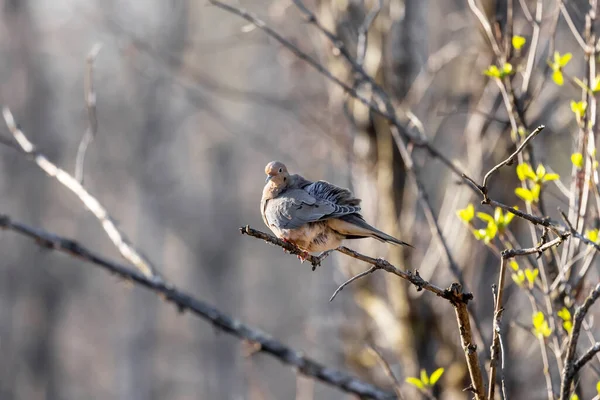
[{"xmin": 320, "ymin": 1, "xmax": 425, "ymax": 382}]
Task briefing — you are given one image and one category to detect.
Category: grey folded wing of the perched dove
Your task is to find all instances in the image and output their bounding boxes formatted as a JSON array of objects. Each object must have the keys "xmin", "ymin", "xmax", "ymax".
[{"xmin": 265, "ymin": 186, "xmax": 360, "ymax": 229}]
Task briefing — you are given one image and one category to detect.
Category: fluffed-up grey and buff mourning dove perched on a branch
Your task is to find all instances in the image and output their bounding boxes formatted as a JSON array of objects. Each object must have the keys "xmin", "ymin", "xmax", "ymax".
[{"xmin": 260, "ymin": 161, "xmax": 412, "ymax": 258}]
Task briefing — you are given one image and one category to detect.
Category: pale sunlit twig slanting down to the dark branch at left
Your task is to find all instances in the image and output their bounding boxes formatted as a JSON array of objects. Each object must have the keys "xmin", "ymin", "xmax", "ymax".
[{"xmin": 2, "ymin": 107, "xmax": 159, "ymax": 279}]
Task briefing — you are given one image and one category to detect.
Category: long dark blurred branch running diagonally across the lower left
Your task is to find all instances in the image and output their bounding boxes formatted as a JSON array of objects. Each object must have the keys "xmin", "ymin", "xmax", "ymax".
[{"xmin": 0, "ymin": 215, "xmax": 396, "ymax": 400}]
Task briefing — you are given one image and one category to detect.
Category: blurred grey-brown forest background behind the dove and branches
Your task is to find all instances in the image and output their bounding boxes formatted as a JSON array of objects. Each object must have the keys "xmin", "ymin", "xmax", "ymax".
[{"xmin": 0, "ymin": 0, "xmax": 597, "ymax": 400}]
